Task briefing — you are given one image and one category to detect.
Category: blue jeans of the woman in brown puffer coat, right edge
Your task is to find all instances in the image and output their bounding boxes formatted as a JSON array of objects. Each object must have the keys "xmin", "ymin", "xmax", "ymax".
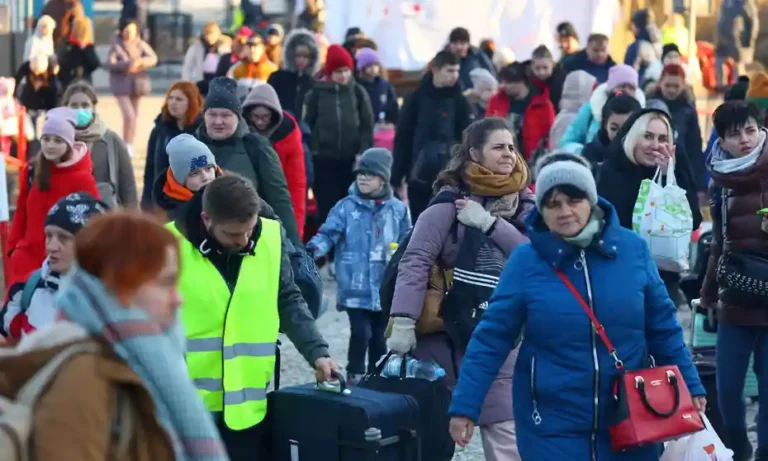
[{"xmin": 716, "ymin": 323, "xmax": 768, "ymax": 454}]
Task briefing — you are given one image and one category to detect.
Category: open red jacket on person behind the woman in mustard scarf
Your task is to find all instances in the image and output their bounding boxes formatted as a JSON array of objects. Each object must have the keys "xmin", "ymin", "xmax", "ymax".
[{"xmin": 485, "ymin": 88, "xmax": 555, "ymax": 160}]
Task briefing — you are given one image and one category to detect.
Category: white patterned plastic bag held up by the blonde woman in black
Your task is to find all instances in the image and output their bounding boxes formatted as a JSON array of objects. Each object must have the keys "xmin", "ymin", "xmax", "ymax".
[{"xmin": 632, "ymin": 159, "xmax": 693, "ymax": 272}]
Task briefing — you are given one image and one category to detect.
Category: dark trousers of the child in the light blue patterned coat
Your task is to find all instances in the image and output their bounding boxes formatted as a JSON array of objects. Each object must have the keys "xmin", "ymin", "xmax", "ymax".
[{"xmin": 346, "ymin": 308, "xmax": 389, "ymax": 375}]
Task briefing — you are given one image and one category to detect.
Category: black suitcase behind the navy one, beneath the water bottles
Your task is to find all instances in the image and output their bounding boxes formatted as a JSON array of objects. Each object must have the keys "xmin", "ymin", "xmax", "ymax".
[{"xmin": 358, "ymin": 348, "xmax": 455, "ymax": 461}]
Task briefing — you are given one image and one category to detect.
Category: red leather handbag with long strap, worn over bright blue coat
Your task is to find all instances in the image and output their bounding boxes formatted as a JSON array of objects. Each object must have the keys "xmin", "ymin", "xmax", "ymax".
[{"xmin": 555, "ymin": 270, "xmax": 704, "ymax": 451}]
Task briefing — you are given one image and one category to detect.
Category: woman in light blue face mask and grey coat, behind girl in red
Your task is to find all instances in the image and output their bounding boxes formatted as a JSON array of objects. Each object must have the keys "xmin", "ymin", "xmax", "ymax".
[{"xmin": 61, "ymin": 81, "xmax": 139, "ymax": 207}]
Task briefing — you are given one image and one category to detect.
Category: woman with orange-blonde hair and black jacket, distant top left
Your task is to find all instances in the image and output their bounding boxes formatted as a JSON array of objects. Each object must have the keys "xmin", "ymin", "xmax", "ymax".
[{"xmin": 59, "ymin": 16, "xmax": 101, "ymax": 88}]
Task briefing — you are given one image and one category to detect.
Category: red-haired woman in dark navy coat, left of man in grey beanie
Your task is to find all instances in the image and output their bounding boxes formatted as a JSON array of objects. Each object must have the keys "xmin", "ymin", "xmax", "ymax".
[{"xmin": 141, "ymin": 80, "xmax": 203, "ymax": 210}]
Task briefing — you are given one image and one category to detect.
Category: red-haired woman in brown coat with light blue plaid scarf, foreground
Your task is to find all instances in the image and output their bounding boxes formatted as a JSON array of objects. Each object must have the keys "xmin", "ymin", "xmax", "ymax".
[{"xmin": 0, "ymin": 211, "xmax": 229, "ymax": 461}]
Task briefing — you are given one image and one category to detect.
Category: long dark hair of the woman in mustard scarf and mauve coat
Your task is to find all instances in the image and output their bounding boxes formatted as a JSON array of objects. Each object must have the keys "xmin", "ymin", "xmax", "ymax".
[{"xmin": 432, "ymin": 117, "xmax": 517, "ymax": 192}]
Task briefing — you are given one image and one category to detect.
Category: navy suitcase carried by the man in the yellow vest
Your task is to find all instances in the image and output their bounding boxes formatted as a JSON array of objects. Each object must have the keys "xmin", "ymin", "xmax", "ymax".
[{"xmin": 267, "ymin": 370, "xmax": 421, "ymax": 461}]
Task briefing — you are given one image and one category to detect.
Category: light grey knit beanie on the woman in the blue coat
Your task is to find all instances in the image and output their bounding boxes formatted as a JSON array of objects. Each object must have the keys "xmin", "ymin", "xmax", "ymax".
[{"xmin": 536, "ymin": 152, "xmax": 597, "ymax": 209}]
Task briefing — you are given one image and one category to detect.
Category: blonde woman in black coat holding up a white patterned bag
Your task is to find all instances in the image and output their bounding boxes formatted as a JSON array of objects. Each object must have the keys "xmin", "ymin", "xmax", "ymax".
[{"xmin": 597, "ymin": 109, "xmax": 701, "ymax": 305}]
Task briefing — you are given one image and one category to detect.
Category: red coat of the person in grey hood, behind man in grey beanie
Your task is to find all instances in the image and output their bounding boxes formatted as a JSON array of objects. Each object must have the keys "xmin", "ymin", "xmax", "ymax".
[{"xmin": 269, "ymin": 111, "xmax": 307, "ymax": 238}]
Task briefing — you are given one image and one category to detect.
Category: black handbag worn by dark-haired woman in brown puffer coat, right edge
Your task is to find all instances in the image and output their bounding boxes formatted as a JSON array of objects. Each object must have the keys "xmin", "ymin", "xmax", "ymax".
[{"xmin": 717, "ymin": 188, "xmax": 768, "ymax": 306}]
